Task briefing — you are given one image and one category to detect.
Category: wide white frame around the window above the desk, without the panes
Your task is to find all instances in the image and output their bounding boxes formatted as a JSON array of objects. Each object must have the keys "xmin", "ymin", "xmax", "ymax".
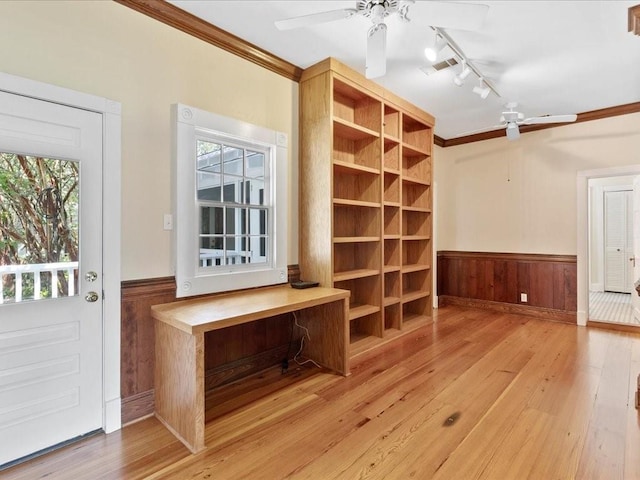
[{"xmin": 172, "ymin": 104, "xmax": 288, "ymax": 298}]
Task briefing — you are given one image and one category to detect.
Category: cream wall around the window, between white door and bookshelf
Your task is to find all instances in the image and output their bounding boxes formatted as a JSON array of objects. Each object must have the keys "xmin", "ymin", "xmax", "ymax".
[{"xmin": 0, "ymin": 0, "xmax": 298, "ymax": 280}]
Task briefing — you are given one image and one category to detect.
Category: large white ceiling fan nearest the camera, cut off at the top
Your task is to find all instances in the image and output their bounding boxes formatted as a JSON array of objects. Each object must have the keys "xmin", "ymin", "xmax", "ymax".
[{"xmin": 275, "ymin": 0, "xmax": 489, "ymax": 78}]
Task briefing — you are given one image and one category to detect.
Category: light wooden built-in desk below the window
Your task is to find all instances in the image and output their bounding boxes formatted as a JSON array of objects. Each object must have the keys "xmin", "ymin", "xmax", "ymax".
[{"xmin": 151, "ymin": 285, "xmax": 349, "ymax": 453}]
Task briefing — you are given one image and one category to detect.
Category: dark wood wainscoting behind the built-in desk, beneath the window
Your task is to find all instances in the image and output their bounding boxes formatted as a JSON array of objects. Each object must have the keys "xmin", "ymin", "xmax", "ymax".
[{"xmin": 120, "ymin": 265, "xmax": 300, "ymax": 424}]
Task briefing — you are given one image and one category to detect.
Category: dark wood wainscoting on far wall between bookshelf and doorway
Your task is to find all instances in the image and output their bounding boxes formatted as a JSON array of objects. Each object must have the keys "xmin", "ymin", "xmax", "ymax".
[{"xmin": 438, "ymin": 251, "xmax": 577, "ymax": 323}]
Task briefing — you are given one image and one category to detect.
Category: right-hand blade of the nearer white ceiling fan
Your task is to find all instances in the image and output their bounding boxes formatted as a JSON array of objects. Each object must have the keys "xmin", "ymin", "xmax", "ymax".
[{"xmin": 408, "ymin": 1, "xmax": 489, "ymax": 30}]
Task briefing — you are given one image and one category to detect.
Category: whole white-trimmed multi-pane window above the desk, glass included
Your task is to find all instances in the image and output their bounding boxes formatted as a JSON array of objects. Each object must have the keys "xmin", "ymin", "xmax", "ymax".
[{"xmin": 173, "ymin": 105, "xmax": 287, "ymax": 297}]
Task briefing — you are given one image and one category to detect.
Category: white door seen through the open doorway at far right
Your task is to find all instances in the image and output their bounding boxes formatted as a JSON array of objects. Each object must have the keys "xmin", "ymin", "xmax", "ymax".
[{"xmin": 604, "ymin": 190, "xmax": 633, "ymax": 293}]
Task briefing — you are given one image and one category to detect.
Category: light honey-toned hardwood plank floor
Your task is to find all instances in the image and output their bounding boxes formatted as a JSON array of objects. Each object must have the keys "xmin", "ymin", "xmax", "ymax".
[{"xmin": 0, "ymin": 307, "xmax": 640, "ymax": 480}]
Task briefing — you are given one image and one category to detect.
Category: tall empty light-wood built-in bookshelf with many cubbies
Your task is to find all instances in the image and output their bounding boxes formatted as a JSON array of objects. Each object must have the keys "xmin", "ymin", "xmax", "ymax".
[{"xmin": 299, "ymin": 59, "xmax": 434, "ymax": 357}]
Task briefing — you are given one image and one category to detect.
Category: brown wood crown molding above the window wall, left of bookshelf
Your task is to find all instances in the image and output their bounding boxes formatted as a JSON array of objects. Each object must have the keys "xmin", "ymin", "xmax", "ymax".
[{"xmin": 114, "ymin": 0, "xmax": 302, "ymax": 82}]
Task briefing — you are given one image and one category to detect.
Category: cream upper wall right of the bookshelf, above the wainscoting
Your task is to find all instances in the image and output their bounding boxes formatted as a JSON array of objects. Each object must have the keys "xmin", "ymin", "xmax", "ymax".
[{"xmin": 434, "ymin": 113, "xmax": 640, "ymax": 254}]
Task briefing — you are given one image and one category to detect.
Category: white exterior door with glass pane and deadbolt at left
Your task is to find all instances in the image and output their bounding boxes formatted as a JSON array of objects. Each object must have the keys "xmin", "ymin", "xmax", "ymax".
[{"xmin": 0, "ymin": 92, "xmax": 103, "ymax": 465}]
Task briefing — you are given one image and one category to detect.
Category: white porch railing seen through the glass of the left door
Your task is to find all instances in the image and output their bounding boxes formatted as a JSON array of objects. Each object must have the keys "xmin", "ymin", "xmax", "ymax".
[{"xmin": 0, "ymin": 262, "xmax": 78, "ymax": 305}]
